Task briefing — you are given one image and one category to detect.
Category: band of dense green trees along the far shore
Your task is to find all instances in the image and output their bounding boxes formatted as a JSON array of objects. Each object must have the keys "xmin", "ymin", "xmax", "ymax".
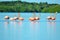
[{"xmin": 0, "ymin": 1, "xmax": 60, "ymax": 12}]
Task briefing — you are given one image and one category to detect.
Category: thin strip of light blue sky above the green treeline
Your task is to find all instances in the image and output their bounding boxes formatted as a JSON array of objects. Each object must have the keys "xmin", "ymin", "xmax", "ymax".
[{"xmin": 0, "ymin": 0, "xmax": 60, "ymax": 4}]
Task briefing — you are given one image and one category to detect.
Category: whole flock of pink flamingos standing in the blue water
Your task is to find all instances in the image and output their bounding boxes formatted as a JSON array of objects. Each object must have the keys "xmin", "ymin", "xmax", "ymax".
[{"xmin": 4, "ymin": 12, "xmax": 57, "ymax": 21}]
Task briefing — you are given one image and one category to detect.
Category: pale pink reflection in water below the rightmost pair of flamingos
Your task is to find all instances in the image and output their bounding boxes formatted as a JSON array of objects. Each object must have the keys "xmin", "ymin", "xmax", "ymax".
[{"xmin": 47, "ymin": 21, "xmax": 56, "ymax": 40}]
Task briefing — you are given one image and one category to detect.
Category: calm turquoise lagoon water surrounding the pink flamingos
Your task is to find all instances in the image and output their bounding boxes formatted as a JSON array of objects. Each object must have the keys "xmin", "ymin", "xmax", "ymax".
[{"xmin": 0, "ymin": 13, "xmax": 60, "ymax": 40}]
